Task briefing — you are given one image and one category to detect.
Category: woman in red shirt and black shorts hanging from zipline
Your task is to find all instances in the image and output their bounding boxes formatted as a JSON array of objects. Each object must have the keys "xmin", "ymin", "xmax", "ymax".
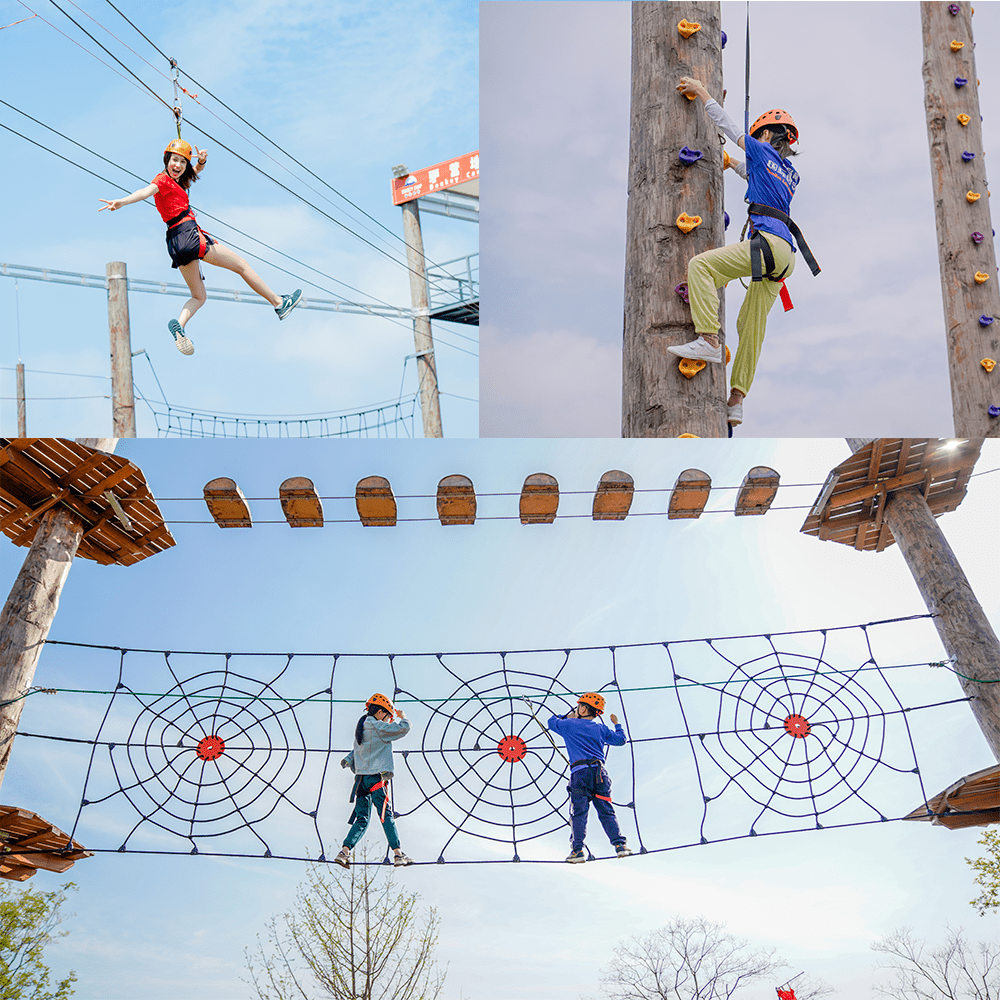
[{"xmin": 97, "ymin": 139, "xmax": 302, "ymax": 354}]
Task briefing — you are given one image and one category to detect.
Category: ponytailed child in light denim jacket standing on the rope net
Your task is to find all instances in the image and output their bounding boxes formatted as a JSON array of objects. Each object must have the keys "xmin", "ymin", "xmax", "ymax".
[{"xmin": 333, "ymin": 692, "xmax": 413, "ymax": 868}]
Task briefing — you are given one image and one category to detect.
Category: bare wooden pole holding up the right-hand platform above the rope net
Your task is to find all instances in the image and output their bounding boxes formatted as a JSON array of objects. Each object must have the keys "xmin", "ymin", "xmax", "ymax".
[{"xmin": 847, "ymin": 438, "xmax": 1000, "ymax": 761}]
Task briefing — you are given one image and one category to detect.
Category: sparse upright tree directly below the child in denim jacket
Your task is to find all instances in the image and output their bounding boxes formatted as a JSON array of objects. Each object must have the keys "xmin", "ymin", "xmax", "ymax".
[{"xmin": 247, "ymin": 852, "xmax": 445, "ymax": 1000}]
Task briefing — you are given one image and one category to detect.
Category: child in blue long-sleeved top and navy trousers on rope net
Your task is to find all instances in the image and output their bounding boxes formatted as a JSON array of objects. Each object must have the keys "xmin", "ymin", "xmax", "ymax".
[{"xmin": 549, "ymin": 691, "xmax": 632, "ymax": 865}]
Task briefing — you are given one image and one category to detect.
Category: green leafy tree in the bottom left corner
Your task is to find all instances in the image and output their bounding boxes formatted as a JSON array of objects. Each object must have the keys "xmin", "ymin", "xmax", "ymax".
[{"xmin": 0, "ymin": 880, "xmax": 76, "ymax": 1000}]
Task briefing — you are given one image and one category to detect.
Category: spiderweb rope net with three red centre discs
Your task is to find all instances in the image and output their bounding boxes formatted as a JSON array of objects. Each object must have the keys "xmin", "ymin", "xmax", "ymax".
[{"xmin": 21, "ymin": 616, "xmax": 967, "ymax": 863}]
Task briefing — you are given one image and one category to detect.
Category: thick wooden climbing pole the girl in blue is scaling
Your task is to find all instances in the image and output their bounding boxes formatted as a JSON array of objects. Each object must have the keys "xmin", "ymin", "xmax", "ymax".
[{"xmin": 622, "ymin": 0, "xmax": 728, "ymax": 437}]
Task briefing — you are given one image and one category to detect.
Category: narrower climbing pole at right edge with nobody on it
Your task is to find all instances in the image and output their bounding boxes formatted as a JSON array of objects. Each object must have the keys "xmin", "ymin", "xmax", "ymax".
[{"xmin": 920, "ymin": 0, "xmax": 1000, "ymax": 438}]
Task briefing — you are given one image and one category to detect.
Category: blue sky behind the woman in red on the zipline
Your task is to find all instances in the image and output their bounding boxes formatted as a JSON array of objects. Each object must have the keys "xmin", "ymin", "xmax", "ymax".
[{"xmin": 0, "ymin": 0, "xmax": 479, "ymax": 437}]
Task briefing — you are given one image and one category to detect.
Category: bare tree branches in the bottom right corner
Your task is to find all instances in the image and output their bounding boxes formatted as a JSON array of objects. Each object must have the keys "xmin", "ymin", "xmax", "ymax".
[{"xmin": 872, "ymin": 927, "xmax": 1000, "ymax": 1000}]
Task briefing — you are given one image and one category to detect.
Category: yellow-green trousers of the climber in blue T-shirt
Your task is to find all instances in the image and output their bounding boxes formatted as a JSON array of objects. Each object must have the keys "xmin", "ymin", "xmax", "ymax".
[{"xmin": 688, "ymin": 233, "xmax": 795, "ymax": 396}]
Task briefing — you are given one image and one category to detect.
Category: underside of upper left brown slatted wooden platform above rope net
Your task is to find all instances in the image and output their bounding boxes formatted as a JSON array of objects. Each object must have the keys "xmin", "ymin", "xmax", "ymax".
[{"xmin": 0, "ymin": 438, "xmax": 176, "ymax": 566}]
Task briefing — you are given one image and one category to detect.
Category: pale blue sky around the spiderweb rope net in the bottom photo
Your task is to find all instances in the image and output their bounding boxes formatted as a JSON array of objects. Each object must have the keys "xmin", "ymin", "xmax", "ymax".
[{"xmin": 2, "ymin": 440, "xmax": 1000, "ymax": 1000}]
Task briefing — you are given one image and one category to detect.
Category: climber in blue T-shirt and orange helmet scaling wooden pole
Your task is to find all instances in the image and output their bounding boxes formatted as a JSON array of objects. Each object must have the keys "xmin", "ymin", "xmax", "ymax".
[{"xmin": 667, "ymin": 76, "xmax": 820, "ymax": 426}]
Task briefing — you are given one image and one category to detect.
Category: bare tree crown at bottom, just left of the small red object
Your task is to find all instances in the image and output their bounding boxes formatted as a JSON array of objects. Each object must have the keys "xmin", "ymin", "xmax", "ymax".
[{"xmin": 601, "ymin": 917, "xmax": 830, "ymax": 1000}]
